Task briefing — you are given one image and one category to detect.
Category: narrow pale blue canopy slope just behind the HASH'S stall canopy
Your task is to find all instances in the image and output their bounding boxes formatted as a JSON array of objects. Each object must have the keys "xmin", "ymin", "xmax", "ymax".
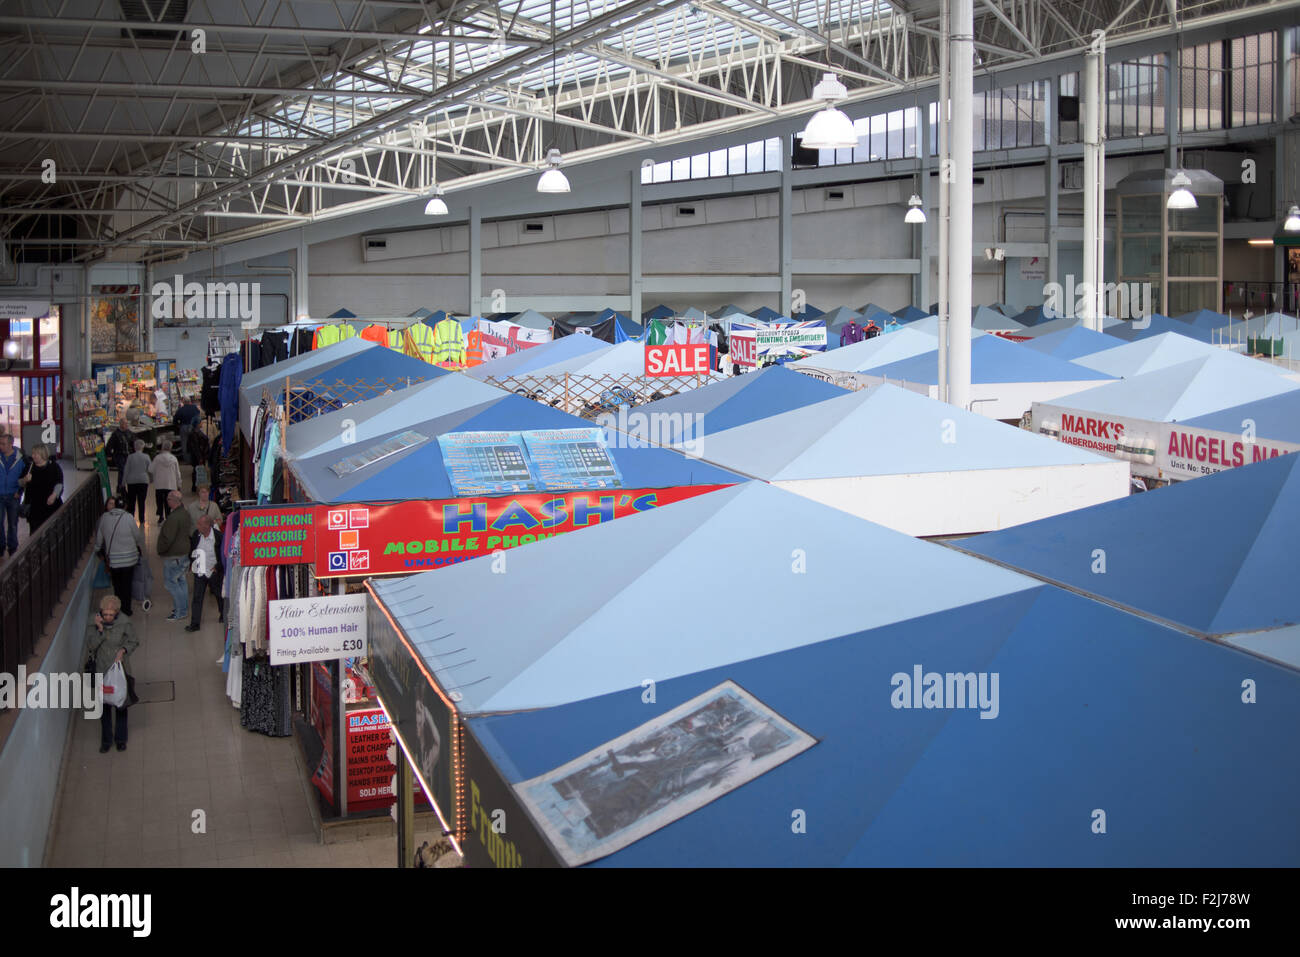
[{"xmin": 285, "ymin": 376, "xmax": 506, "ymax": 459}]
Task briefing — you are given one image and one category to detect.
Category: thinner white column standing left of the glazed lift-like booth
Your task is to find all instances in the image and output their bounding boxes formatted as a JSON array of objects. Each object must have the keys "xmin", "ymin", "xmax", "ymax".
[{"xmin": 1082, "ymin": 30, "xmax": 1106, "ymax": 332}]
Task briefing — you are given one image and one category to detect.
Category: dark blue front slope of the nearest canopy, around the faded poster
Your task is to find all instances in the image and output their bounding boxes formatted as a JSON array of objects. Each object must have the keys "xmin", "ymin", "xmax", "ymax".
[{"xmin": 467, "ymin": 574, "xmax": 1300, "ymax": 867}]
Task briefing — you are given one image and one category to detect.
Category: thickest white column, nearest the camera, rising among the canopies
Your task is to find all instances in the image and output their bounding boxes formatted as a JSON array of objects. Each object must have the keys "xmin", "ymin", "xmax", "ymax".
[{"xmin": 948, "ymin": 0, "xmax": 975, "ymax": 408}]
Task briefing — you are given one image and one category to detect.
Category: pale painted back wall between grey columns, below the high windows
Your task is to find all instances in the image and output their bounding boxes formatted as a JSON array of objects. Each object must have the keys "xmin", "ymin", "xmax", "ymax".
[{"xmin": 309, "ymin": 148, "xmax": 1170, "ymax": 317}]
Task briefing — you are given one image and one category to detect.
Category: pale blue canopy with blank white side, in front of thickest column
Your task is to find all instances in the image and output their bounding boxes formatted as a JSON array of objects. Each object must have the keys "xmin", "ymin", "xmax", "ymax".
[{"xmin": 703, "ymin": 382, "xmax": 1128, "ymax": 536}]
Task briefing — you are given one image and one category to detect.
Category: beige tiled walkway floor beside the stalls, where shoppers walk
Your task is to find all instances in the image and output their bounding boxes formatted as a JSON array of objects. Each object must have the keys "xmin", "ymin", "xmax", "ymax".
[{"xmin": 47, "ymin": 476, "xmax": 410, "ymax": 867}]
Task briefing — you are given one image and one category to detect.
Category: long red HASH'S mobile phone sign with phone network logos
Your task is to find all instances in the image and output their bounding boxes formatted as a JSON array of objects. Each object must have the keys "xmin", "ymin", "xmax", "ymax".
[{"xmin": 316, "ymin": 486, "xmax": 725, "ymax": 577}]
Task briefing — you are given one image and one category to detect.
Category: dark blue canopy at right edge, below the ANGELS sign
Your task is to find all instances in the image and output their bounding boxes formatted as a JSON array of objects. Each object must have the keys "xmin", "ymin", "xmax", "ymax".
[{"xmin": 959, "ymin": 455, "xmax": 1300, "ymax": 647}]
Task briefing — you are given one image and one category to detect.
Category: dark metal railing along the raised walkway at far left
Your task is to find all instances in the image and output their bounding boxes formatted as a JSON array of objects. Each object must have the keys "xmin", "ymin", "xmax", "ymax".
[{"xmin": 0, "ymin": 480, "xmax": 104, "ymax": 696}]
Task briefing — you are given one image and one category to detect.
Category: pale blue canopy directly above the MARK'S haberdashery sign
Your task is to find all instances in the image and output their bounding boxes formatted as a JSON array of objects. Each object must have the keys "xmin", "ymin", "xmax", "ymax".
[{"xmin": 1050, "ymin": 351, "xmax": 1297, "ymax": 423}]
